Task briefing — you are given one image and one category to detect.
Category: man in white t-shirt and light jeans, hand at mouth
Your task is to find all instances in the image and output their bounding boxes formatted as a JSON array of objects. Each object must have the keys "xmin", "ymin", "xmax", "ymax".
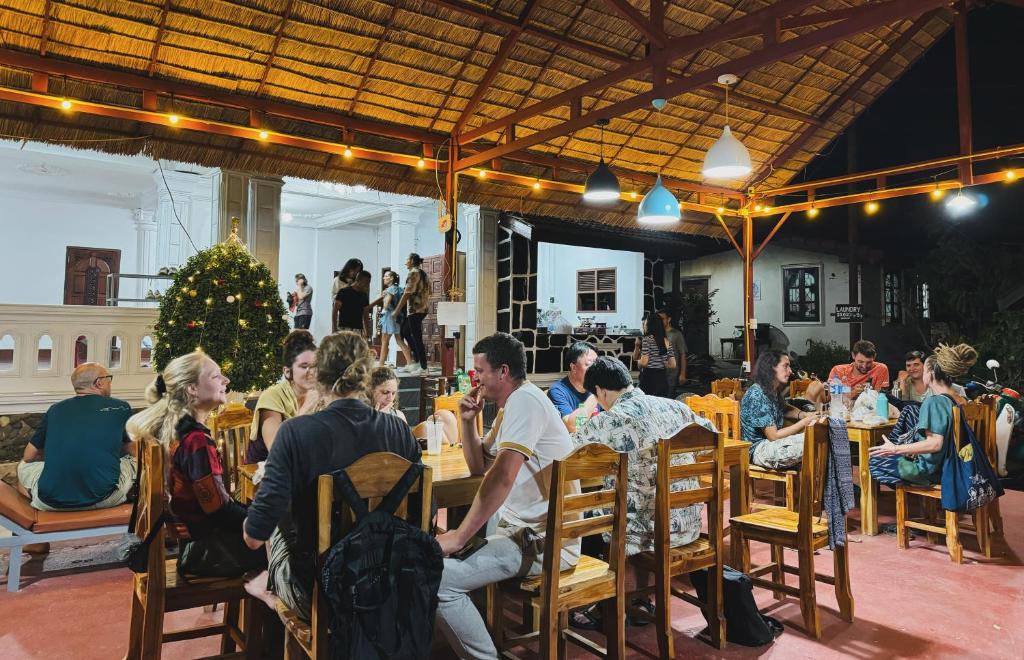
[{"xmin": 437, "ymin": 333, "xmax": 580, "ymax": 658}]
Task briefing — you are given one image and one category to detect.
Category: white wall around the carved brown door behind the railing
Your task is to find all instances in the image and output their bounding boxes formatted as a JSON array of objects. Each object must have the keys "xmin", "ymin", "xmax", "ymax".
[{"xmin": 0, "ymin": 194, "xmax": 137, "ymax": 305}]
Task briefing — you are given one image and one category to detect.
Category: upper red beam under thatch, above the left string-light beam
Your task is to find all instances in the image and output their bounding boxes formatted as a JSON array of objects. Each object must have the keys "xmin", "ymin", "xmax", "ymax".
[{"xmin": 0, "ymin": 48, "xmax": 449, "ymax": 144}]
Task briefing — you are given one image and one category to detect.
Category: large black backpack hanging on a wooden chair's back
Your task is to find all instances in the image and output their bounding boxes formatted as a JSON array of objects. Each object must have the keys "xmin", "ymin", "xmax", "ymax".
[{"xmin": 321, "ymin": 464, "xmax": 444, "ymax": 660}]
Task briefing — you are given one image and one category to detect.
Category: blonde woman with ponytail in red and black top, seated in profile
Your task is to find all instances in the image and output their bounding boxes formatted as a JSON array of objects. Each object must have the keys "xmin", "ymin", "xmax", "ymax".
[{"xmin": 127, "ymin": 351, "xmax": 266, "ymax": 577}]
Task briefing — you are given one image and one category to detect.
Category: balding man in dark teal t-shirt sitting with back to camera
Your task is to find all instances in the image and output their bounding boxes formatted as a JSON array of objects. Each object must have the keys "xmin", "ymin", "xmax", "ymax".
[{"xmin": 17, "ymin": 362, "xmax": 136, "ymax": 511}]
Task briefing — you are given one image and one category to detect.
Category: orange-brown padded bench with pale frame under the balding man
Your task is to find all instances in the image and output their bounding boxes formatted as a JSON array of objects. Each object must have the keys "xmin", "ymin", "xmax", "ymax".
[{"xmin": 0, "ymin": 481, "xmax": 131, "ymax": 591}]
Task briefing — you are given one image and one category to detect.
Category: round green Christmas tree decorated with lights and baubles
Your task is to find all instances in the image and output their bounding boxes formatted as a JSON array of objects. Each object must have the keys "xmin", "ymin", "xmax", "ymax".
[{"xmin": 154, "ymin": 219, "xmax": 288, "ymax": 392}]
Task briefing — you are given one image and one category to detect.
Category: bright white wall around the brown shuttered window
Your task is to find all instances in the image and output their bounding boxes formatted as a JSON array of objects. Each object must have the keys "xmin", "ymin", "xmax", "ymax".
[{"xmin": 537, "ymin": 243, "xmax": 643, "ymax": 327}]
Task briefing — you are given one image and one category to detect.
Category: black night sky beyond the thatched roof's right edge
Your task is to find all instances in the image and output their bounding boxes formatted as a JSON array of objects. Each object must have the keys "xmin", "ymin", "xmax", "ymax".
[{"xmin": 770, "ymin": 3, "xmax": 1024, "ymax": 261}]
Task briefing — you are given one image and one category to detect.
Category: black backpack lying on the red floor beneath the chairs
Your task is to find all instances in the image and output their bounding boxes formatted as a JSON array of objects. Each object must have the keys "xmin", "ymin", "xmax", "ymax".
[{"xmin": 690, "ymin": 566, "xmax": 782, "ymax": 647}]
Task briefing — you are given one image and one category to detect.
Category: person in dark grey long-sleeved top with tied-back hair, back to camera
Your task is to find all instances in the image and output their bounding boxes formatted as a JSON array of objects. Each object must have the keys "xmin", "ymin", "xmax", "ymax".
[{"xmin": 244, "ymin": 331, "xmax": 421, "ymax": 621}]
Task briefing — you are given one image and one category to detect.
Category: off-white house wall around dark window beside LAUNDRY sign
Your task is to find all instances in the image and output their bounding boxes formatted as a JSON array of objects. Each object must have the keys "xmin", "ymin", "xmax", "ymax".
[{"xmin": 666, "ymin": 245, "xmax": 850, "ymax": 354}]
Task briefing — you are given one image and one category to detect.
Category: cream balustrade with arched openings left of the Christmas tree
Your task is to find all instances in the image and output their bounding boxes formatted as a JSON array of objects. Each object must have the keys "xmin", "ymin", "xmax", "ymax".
[{"xmin": 0, "ymin": 305, "xmax": 158, "ymax": 413}]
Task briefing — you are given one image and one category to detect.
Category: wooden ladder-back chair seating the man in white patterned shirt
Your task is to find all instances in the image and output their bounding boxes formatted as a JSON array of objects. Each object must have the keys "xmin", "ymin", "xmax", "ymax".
[{"xmin": 629, "ymin": 425, "xmax": 725, "ymax": 658}]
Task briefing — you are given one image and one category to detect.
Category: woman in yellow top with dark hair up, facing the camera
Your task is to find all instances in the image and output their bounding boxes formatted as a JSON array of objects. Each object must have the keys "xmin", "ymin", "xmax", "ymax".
[{"xmin": 246, "ymin": 329, "xmax": 317, "ymax": 464}]
